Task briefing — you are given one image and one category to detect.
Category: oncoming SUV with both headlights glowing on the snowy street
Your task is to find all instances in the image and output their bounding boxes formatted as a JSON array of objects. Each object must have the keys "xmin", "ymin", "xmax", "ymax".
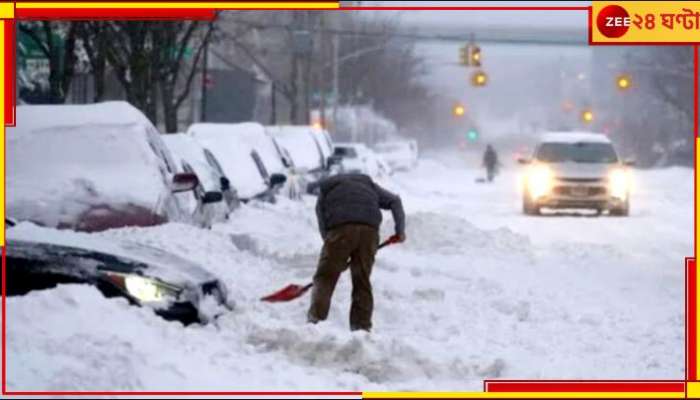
[{"xmin": 519, "ymin": 132, "xmax": 633, "ymax": 216}]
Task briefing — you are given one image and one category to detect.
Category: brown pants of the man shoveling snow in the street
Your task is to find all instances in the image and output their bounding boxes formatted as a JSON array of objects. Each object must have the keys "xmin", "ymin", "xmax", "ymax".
[{"xmin": 308, "ymin": 224, "xmax": 379, "ymax": 331}]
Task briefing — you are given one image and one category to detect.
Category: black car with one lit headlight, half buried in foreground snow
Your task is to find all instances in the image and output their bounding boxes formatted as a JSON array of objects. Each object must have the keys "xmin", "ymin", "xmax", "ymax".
[{"xmin": 5, "ymin": 221, "xmax": 232, "ymax": 324}]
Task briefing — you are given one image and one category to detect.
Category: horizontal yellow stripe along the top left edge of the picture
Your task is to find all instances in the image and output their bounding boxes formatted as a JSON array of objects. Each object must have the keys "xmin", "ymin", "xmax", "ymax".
[{"xmin": 17, "ymin": 1, "xmax": 340, "ymax": 9}]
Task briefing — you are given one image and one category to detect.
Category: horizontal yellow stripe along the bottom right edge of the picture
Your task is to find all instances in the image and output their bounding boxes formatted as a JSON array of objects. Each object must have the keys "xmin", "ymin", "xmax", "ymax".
[{"xmin": 362, "ymin": 392, "xmax": 685, "ymax": 399}]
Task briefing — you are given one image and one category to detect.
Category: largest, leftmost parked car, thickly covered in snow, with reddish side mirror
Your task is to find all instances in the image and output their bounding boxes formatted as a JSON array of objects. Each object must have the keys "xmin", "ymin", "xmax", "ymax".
[{"xmin": 7, "ymin": 102, "xmax": 198, "ymax": 231}]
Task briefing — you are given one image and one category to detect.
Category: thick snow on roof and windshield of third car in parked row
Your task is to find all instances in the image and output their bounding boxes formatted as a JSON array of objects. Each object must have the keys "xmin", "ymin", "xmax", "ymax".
[{"xmin": 187, "ymin": 123, "xmax": 269, "ymax": 198}]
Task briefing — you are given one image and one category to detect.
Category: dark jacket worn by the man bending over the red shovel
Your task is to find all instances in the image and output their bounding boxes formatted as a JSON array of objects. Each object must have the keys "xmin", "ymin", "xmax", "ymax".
[{"xmin": 316, "ymin": 174, "xmax": 405, "ymax": 239}]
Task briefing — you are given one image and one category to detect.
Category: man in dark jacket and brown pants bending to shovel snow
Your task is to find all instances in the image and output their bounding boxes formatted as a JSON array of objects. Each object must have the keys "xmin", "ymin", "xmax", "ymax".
[{"xmin": 307, "ymin": 174, "xmax": 406, "ymax": 331}]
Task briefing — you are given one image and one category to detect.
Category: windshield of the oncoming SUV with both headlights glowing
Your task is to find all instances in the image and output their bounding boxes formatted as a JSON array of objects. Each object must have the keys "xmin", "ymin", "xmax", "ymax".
[{"xmin": 536, "ymin": 142, "xmax": 617, "ymax": 164}]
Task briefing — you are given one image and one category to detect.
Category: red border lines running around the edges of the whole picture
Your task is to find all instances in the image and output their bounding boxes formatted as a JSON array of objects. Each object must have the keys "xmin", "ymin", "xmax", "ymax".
[{"xmin": 2, "ymin": 6, "xmax": 698, "ymax": 397}]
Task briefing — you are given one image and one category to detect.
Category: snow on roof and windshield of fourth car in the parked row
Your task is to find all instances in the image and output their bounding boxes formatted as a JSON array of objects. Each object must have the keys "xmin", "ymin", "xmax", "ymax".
[{"xmin": 265, "ymin": 125, "xmax": 323, "ymax": 170}]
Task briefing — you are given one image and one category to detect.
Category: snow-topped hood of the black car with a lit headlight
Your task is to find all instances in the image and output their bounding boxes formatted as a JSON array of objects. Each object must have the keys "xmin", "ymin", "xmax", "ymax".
[{"xmin": 6, "ymin": 222, "xmax": 217, "ymax": 286}]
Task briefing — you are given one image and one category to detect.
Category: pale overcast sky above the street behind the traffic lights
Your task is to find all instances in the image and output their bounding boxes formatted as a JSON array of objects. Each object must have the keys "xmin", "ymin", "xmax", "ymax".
[{"xmin": 363, "ymin": 1, "xmax": 592, "ymax": 136}]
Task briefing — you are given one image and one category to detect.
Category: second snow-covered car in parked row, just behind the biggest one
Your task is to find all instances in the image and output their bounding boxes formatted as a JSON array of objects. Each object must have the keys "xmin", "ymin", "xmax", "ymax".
[{"xmin": 162, "ymin": 133, "xmax": 239, "ymax": 228}]
